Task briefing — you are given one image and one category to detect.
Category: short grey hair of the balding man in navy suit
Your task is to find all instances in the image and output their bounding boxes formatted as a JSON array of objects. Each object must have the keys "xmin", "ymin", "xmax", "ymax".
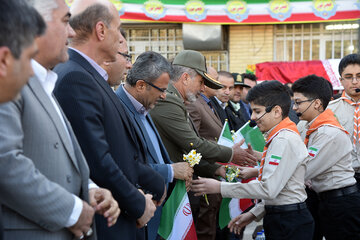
[{"xmin": 70, "ymin": 4, "xmax": 113, "ymax": 43}]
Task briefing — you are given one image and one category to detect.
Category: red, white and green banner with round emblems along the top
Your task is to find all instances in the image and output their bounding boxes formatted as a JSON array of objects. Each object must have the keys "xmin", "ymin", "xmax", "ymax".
[{"xmin": 66, "ymin": 0, "xmax": 360, "ymax": 24}]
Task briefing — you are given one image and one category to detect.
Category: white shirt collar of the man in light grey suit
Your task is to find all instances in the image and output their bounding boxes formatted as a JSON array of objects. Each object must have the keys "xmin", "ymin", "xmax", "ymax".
[{"xmin": 31, "ymin": 59, "xmax": 58, "ymax": 95}]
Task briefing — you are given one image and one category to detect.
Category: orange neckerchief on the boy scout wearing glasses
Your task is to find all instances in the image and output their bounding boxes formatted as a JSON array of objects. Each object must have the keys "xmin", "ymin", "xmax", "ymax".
[{"xmin": 304, "ymin": 109, "xmax": 349, "ymax": 146}]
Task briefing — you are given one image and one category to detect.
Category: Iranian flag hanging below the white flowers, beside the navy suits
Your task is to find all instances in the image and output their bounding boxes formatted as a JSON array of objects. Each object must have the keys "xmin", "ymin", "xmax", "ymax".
[{"xmin": 158, "ymin": 180, "xmax": 197, "ymax": 240}]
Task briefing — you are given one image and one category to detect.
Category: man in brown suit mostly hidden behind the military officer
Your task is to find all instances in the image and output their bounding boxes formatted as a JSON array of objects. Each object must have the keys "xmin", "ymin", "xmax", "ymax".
[{"xmin": 186, "ymin": 66, "xmax": 226, "ymax": 240}]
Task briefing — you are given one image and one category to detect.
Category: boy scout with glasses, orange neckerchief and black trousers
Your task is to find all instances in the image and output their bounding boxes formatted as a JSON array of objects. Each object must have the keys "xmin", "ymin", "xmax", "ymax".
[{"xmin": 292, "ymin": 75, "xmax": 360, "ymax": 240}]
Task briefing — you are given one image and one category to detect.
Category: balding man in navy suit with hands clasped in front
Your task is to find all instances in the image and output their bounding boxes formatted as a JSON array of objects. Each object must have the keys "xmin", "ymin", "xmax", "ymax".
[{"xmin": 54, "ymin": 0, "xmax": 166, "ymax": 240}]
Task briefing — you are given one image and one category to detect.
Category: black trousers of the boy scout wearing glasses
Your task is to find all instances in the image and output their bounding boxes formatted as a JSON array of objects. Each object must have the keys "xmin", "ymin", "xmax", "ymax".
[{"xmin": 319, "ymin": 192, "xmax": 360, "ymax": 240}]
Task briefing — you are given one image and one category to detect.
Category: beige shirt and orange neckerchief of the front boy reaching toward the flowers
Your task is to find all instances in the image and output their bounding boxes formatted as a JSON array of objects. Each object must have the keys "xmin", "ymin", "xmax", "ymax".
[{"xmin": 221, "ymin": 117, "xmax": 308, "ymax": 219}]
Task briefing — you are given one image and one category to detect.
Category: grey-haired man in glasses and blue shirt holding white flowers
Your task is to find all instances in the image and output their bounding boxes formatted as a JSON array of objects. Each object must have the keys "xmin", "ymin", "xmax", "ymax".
[{"xmin": 116, "ymin": 52, "xmax": 193, "ymax": 239}]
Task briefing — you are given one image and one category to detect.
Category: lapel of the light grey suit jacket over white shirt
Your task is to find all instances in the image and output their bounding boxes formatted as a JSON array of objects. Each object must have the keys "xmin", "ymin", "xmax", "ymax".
[{"xmin": 28, "ymin": 77, "xmax": 80, "ymax": 172}]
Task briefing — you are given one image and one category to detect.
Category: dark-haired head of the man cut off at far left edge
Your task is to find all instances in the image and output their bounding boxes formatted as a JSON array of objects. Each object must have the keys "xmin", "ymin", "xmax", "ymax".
[{"xmin": 0, "ymin": 0, "xmax": 45, "ymax": 240}]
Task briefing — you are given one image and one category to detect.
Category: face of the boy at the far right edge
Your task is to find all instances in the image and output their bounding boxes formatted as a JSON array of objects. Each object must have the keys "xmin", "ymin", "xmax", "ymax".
[{"xmin": 340, "ymin": 64, "xmax": 360, "ymax": 99}]
